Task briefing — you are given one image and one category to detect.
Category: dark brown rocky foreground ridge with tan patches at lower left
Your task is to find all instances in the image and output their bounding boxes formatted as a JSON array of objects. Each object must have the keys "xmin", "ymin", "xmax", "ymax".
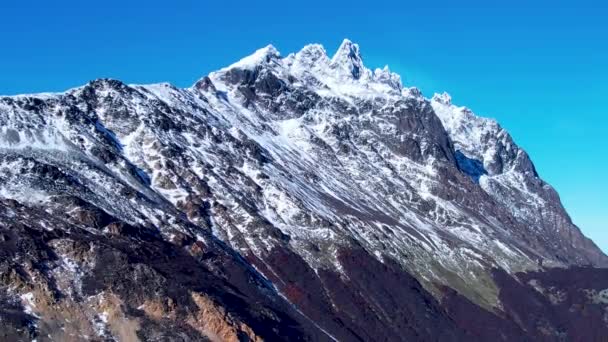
[{"xmin": 0, "ymin": 200, "xmax": 325, "ymax": 341}]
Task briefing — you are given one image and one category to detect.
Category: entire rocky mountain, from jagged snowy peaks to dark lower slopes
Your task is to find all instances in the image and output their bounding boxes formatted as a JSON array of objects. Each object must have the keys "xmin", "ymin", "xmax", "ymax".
[{"xmin": 0, "ymin": 40, "xmax": 608, "ymax": 341}]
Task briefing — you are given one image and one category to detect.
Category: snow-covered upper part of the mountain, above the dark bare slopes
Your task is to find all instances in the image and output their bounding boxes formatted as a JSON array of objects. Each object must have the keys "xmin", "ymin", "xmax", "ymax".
[{"xmin": 0, "ymin": 40, "xmax": 608, "ymax": 340}]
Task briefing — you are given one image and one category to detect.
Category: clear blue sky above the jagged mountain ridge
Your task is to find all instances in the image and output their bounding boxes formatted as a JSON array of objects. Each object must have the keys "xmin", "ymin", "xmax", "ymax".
[{"xmin": 0, "ymin": 0, "xmax": 608, "ymax": 251}]
